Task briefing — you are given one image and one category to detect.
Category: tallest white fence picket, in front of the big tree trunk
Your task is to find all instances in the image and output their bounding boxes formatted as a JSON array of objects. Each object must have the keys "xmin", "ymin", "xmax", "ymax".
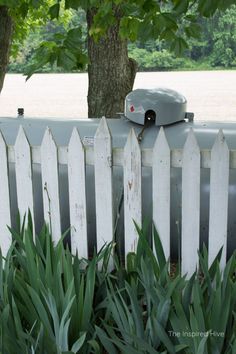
[{"xmin": 94, "ymin": 117, "xmax": 114, "ymax": 250}]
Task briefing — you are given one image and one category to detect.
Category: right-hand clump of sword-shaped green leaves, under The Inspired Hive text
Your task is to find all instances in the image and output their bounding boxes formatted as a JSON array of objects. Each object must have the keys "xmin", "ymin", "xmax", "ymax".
[{"xmin": 96, "ymin": 225, "xmax": 236, "ymax": 354}]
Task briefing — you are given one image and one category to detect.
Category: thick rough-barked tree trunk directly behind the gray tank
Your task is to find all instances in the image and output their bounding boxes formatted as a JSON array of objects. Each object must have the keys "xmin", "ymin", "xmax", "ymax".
[{"xmin": 87, "ymin": 10, "xmax": 137, "ymax": 118}]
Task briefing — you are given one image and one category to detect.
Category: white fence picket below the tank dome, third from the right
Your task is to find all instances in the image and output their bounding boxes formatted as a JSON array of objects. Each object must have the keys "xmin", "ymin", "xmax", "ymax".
[{"xmin": 152, "ymin": 127, "xmax": 170, "ymax": 259}]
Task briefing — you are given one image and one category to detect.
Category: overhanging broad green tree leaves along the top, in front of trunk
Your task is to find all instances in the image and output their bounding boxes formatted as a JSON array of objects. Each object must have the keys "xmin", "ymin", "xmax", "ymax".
[{"xmin": 16, "ymin": 0, "xmax": 234, "ymax": 76}]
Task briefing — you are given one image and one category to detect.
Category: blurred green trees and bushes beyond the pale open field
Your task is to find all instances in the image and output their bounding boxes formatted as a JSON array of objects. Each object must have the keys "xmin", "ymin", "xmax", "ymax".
[{"xmin": 8, "ymin": 5, "xmax": 236, "ymax": 73}]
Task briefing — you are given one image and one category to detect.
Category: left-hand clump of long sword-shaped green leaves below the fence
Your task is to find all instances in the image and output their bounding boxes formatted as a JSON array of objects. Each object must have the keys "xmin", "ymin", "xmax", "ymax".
[{"xmin": 0, "ymin": 214, "xmax": 109, "ymax": 354}]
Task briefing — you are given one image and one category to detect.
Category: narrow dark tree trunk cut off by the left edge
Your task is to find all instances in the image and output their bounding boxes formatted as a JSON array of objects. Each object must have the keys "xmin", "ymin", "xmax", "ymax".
[{"xmin": 0, "ymin": 6, "xmax": 13, "ymax": 93}]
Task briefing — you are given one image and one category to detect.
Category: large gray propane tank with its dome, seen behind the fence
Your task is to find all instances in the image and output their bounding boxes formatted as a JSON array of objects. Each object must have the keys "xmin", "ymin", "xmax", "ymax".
[{"xmin": 0, "ymin": 88, "xmax": 236, "ymax": 258}]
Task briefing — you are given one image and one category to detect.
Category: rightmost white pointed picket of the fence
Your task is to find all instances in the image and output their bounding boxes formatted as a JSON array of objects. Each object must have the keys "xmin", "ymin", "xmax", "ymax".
[{"xmin": 208, "ymin": 129, "xmax": 229, "ymax": 267}]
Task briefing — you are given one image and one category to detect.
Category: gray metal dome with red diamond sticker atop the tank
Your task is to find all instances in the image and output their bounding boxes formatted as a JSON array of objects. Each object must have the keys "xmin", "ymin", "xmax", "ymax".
[{"xmin": 125, "ymin": 87, "xmax": 187, "ymax": 126}]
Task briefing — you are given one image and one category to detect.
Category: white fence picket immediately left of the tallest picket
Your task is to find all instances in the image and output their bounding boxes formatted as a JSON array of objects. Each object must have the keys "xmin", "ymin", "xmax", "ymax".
[{"xmin": 68, "ymin": 128, "xmax": 88, "ymax": 258}]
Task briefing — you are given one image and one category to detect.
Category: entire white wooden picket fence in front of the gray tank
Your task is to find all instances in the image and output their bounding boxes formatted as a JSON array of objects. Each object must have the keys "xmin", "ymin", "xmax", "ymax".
[{"xmin": 0, "ymin": 118, "xmax": 233, "ymax": 275}]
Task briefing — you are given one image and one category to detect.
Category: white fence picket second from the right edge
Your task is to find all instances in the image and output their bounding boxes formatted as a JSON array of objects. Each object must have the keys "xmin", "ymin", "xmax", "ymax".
[{"xmin": 181, "ymin": 129, "xmax": 200, "ymax": 277}]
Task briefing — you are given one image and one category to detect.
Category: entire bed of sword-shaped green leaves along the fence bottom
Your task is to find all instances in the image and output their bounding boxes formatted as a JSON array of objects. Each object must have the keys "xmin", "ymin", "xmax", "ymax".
[{"xmin": 0, "ymin": 215, "xmax": 236, "ymax": 354}]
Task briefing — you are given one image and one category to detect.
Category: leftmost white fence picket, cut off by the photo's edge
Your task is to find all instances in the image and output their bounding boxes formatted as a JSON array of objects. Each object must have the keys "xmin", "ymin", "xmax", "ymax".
[{"xmin": 0, "ymin": 132, "xmax": 11, "ymax": 256}]
